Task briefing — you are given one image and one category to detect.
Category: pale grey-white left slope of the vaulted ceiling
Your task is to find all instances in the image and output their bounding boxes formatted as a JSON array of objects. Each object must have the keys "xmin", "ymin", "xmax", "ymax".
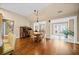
[{"xmin": 1, "ymin": 3, "xmax": 49, "ymax": 16}]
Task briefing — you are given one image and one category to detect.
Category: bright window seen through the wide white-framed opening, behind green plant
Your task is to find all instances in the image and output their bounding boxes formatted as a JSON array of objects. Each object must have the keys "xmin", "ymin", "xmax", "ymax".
[{"xmin": 52, "ymin": 22, "xmax": 68, "ymax": 35}]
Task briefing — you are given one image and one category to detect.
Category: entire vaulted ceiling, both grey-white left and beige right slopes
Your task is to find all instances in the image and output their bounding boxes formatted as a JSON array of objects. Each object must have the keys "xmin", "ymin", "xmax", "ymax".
[{"xmin": 0, "ymin": 3, "xmax": 79, "ymax": 21}]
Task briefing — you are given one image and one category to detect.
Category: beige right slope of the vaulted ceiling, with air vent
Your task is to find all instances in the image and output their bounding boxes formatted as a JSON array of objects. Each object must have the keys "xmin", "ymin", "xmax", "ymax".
[{"xmin": 39, "ymin": 3, "xmax": 79, "ymax": 20}]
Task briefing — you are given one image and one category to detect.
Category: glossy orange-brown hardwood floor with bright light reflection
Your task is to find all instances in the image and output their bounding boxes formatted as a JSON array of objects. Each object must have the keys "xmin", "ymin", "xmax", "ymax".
[{"xmin": 13, "ymin": 38, "xmax": 79, "ymax": 55}]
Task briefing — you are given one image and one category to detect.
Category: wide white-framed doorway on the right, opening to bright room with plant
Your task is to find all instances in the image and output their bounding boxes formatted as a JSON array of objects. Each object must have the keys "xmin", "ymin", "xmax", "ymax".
[{"xmin": 50, "ymin": 16, "xmax": 77, "ymax": 43}]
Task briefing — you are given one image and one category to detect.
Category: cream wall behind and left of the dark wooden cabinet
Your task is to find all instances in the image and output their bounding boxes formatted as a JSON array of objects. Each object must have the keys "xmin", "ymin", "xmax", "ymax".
[{"xmin": 0, "ymin": 9, "xmax": 30, "ymax": 38}]
